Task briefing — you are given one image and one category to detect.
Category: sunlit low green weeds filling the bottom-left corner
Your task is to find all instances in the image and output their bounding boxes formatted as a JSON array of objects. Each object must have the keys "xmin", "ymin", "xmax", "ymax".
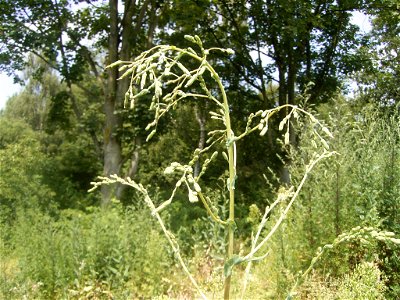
[{"xmin": 0, "ymin": 204, "xmax": 172, "ymax": 299}]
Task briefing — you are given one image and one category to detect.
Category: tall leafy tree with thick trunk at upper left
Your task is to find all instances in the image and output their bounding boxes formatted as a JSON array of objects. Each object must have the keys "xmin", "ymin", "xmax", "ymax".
[{"xmin": 0, "ymin": 0, "xmax": 162, "ymax": 205}]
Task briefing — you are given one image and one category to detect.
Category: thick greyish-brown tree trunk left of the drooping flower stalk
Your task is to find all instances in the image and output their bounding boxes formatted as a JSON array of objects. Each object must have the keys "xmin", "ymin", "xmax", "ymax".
[{"xmin": 102, "ymin": 0, "xmax": 157, "ymax": 207}]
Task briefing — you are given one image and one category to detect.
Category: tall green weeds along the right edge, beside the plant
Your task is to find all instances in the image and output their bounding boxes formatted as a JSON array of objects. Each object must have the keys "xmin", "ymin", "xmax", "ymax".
[{"xmin": 281, "ymin": 96, "xmax": 400, "ymax": 299}]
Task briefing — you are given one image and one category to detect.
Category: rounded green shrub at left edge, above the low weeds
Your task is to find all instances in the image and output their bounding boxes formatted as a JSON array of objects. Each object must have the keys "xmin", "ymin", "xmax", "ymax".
[{"xmin": 0, "ymin": 117, "xmax": 55, "ymax": 224}]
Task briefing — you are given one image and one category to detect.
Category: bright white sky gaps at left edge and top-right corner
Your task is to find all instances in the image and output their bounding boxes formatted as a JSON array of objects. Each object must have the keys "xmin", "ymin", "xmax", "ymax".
[{"xmin": 0, "ymin": 12, "xmax": 371, "ymax": 110}]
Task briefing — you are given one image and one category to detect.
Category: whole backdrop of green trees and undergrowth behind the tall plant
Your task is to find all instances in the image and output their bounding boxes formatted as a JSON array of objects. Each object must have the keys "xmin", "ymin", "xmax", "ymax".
[{"xmin": 0, "ymin": 0, "xmax": 400, "ymax": 299}]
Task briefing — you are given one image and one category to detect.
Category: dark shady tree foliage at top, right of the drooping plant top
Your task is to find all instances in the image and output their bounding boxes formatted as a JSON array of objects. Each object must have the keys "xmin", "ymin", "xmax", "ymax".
[{"xmin": 158, "ymin": 0, "xmax": 366, "ymax": 182}]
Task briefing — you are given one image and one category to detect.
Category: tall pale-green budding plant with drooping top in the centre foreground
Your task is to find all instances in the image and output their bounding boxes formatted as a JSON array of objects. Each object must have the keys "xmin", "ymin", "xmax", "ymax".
[{"xmin": 92, "ymin": 36, "xmax": 333, "ymax": 299}]
